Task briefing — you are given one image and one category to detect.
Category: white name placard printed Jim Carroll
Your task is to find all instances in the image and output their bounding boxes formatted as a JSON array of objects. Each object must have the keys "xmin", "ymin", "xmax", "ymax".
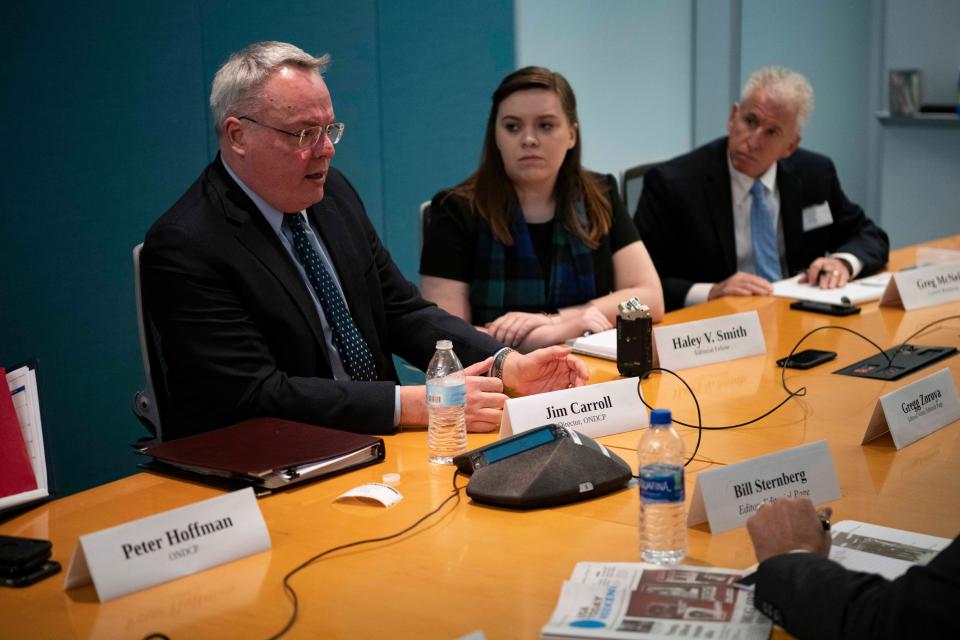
[{"xmin": 500, "ymin": 378, "xmax": 650, "ymax": 438}]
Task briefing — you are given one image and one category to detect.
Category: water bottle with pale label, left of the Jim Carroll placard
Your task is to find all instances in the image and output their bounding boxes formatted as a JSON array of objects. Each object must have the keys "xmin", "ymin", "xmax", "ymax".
[{"xmin": 427, "ymin": 340, "xmax": 467, "ymax": 464}]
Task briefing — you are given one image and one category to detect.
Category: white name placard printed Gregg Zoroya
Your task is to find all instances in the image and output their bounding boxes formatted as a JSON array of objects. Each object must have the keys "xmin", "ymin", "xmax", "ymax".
[{"xmin": 861, "ymin": 369, "xmax": 960, "ymax": 449}]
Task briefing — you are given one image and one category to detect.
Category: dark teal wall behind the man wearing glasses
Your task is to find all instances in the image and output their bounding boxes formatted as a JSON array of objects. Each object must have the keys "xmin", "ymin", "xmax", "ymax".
[{"xmin": 0, "ymin": 0, "xmax": 514, "ymax": 495}]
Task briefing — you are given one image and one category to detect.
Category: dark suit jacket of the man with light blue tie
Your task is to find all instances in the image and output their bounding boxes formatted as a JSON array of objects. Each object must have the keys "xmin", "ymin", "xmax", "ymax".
[{"xmin": 634, "ymin": 138, "xmax": 890, "ymax": 311}]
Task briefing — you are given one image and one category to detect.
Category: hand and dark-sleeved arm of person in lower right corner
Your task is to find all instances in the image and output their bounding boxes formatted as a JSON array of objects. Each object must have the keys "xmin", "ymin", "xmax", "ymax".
[{"xmin": 747, "ymin": 498, "xmax": 960, "ymax": 640}]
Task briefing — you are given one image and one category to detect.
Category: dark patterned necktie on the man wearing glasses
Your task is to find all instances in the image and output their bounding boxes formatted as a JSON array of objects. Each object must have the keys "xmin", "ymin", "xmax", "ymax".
[{"xmin": 283, "ymin": 213, "xmax": 377, "ymax": 380}]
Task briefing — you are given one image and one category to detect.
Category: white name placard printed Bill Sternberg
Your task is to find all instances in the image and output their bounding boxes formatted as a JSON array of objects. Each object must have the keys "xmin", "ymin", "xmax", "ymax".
[{"xmin": 687, "ymin": 440, "xmax": 840, "ymax": 533}]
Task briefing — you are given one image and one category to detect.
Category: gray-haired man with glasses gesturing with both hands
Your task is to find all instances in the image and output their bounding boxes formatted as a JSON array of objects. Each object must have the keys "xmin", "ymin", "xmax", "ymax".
[{"xmin": 141, "ymin": 42, "xmax": 587, "ymax": 439}]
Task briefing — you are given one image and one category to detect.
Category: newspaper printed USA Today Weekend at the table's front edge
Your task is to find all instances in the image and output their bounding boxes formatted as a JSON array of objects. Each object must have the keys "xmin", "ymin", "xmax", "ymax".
[{"xmin": 540, "ymin": 562, "xmax": 771, "ymax": 640}]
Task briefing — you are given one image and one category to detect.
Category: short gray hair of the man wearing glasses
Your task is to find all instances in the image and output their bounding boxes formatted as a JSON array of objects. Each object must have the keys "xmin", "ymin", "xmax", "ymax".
[{"xmin": 210, "ymin": 41, "xmax": 330, "ymax": 137}]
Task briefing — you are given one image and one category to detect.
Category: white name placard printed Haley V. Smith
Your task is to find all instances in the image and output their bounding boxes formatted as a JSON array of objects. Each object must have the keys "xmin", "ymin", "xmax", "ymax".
[{"xmin": 653, "ymin": 311, "xmax": 767, "ymax": 370}]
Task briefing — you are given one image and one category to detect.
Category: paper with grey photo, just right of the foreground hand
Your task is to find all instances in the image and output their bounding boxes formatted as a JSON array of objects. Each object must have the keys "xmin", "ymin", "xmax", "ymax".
[{"xmin": 830, "ymin": 520, "xmax": 950, "ymax": 580}]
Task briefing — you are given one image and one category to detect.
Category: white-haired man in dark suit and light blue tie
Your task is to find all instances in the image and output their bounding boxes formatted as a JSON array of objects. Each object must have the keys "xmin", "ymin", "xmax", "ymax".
[{"xmin": 634, "ymin": 67, "xmax": 890, "ymax": 311}]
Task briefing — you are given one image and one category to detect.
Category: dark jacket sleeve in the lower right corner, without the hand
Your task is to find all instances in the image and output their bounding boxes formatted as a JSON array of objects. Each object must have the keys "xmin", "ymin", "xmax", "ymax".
[{"xmin": 755, "ymin": 538, "xmax": 960, "ymax": 640}]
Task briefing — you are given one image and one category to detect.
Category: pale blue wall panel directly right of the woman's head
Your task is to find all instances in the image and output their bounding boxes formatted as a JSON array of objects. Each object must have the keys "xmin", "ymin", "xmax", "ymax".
[{"xmin": 516, "ymin": 0, "xmax": 693, "ymax": 176}]
